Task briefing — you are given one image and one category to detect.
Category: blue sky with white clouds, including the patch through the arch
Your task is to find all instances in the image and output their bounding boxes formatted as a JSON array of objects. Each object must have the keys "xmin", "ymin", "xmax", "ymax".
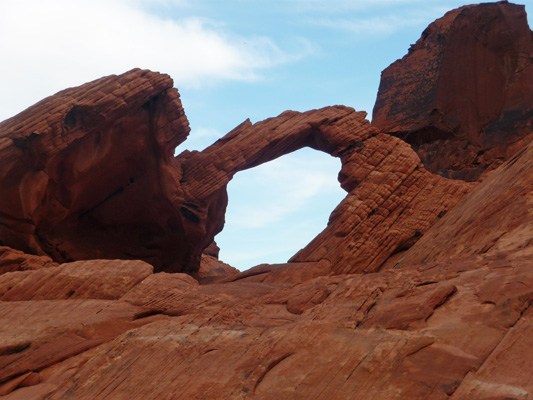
[{"xmin": 0, "ymin": 0, "xmax": 531, "ymax": 269}]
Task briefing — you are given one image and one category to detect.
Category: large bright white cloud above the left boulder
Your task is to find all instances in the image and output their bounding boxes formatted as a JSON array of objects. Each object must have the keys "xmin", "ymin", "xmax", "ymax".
[{"xmin": 0, "ymin": 0, "xmax": 307, "ymax": 120}]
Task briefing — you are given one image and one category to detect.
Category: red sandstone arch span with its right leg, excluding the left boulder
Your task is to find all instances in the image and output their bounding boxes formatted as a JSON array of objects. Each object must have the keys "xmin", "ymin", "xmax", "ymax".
[{"xmin": 182, "ymin": 106, "xmax": 472, "ymax": 274}]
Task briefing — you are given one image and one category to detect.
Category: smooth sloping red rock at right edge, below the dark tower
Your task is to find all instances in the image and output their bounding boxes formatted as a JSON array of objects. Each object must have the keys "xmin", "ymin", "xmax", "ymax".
[{"xmin": 386, "ymin": 124, "xmax": 533, "ymax": 267}]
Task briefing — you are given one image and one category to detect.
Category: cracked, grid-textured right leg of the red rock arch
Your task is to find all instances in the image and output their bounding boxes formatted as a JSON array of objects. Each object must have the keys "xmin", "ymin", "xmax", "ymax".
[{"xmin": 291, "ymin": 134, "xmax": 472, "ymax": 273}]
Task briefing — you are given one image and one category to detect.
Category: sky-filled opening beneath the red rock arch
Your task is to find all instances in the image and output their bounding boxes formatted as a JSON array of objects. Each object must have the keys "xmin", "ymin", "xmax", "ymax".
[{"xmin": 215, "ymin": 148, "xmax": 346, "ymax": 270}]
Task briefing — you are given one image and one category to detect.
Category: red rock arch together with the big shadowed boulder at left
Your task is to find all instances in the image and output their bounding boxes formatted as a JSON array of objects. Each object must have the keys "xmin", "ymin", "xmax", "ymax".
[{"xmin": 0, "ymin": 69, "xmax": 470, "ymax": 274}]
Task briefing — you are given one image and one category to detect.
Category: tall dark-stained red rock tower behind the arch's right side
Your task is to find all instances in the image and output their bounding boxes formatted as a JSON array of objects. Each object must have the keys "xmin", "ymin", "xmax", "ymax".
[{"xmin": 372, "ymin": 2, "xmax": 533, "ymax": 180}]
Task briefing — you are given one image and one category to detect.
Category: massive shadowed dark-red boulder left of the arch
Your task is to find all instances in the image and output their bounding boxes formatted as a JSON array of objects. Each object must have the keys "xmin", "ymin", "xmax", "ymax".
[{"xmin": 0, "ymin": 70, "xmax": 189, "ymax": 269}]
